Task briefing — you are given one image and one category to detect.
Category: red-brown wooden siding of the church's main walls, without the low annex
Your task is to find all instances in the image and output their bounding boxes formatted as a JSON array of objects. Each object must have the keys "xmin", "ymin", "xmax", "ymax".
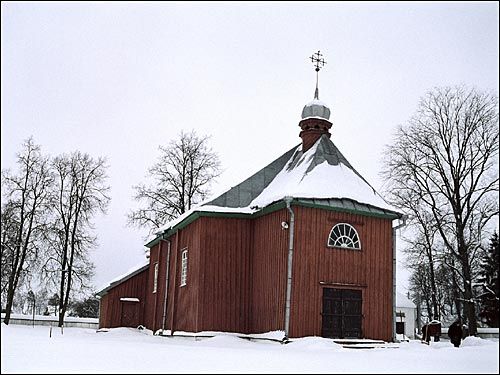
[{"xmin": 97, "ymin": 205, "xmax": 392, "ymax": 340}]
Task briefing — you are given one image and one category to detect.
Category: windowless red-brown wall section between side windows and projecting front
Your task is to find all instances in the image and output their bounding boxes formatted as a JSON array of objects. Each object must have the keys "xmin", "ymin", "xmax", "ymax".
[{"xmin": 196, "ymin": 217, "xmax": 253, "ymax": 333}]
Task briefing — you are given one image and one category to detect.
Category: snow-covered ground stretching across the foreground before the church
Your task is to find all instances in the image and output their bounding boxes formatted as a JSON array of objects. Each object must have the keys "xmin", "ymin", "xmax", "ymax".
[{"xmin": 1, "ymin": 323, "xmax": 499, "ymax": 374}]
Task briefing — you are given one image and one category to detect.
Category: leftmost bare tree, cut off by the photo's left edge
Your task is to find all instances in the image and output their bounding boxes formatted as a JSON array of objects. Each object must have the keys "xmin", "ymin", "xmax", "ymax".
[{"xmin": 1, "ymin": 138, "xmax": 53, "ymax": 324}]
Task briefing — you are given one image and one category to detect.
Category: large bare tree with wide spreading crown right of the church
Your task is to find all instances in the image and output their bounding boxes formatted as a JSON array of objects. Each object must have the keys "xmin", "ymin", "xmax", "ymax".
[{"xmin": 383, "ymin": 87, "xmax": 499, "ymax": 335}]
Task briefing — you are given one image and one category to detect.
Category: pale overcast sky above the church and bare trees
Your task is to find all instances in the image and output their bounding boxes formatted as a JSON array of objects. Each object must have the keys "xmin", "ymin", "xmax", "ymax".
[{"xmin": 1, "ymin": 1, "xmax": 499, "ymax": 290}]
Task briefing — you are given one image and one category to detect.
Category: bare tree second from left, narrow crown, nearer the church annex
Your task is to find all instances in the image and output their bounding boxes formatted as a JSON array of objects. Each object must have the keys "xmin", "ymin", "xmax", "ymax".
[{"xmin": 43, "ymin": 151, "xmax": 110, "ymax": 326}]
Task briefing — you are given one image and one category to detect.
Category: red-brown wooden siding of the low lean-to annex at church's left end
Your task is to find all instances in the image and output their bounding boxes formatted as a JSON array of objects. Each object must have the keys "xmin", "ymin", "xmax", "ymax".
[{"xmin": 99, "ymin": 269, "xmax": 148, "ymax": 328}]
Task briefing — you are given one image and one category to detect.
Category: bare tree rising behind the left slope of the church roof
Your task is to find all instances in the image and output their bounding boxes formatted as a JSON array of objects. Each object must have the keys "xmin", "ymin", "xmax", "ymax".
[{"xmin": 128, "ymin": 131, "xmax": 221, "ymax": 233}]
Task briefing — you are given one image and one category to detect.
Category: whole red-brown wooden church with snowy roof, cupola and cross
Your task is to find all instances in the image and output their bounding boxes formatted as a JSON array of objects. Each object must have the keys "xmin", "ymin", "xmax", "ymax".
[{"xmin": 97, "ymin": 52, "xmax": 402, "ymax": 341}]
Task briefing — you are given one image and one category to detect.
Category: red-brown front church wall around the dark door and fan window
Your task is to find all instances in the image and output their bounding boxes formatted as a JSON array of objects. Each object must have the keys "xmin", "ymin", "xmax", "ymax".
[{"xmin": 290, "ymin": 206, "xmax": 392, "ymax": 340}]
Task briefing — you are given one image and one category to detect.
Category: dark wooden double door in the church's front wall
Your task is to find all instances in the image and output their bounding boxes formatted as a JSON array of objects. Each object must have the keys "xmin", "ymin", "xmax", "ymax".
[{"xmin": 321, "ymin": 288, "xmax": 362, "ymax": 338}]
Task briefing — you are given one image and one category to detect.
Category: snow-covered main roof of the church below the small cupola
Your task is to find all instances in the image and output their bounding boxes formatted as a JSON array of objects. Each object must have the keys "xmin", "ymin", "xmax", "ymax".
[{"xmin": 146, "ymin": 135, "xmax": 401, "ymax": 246}]
